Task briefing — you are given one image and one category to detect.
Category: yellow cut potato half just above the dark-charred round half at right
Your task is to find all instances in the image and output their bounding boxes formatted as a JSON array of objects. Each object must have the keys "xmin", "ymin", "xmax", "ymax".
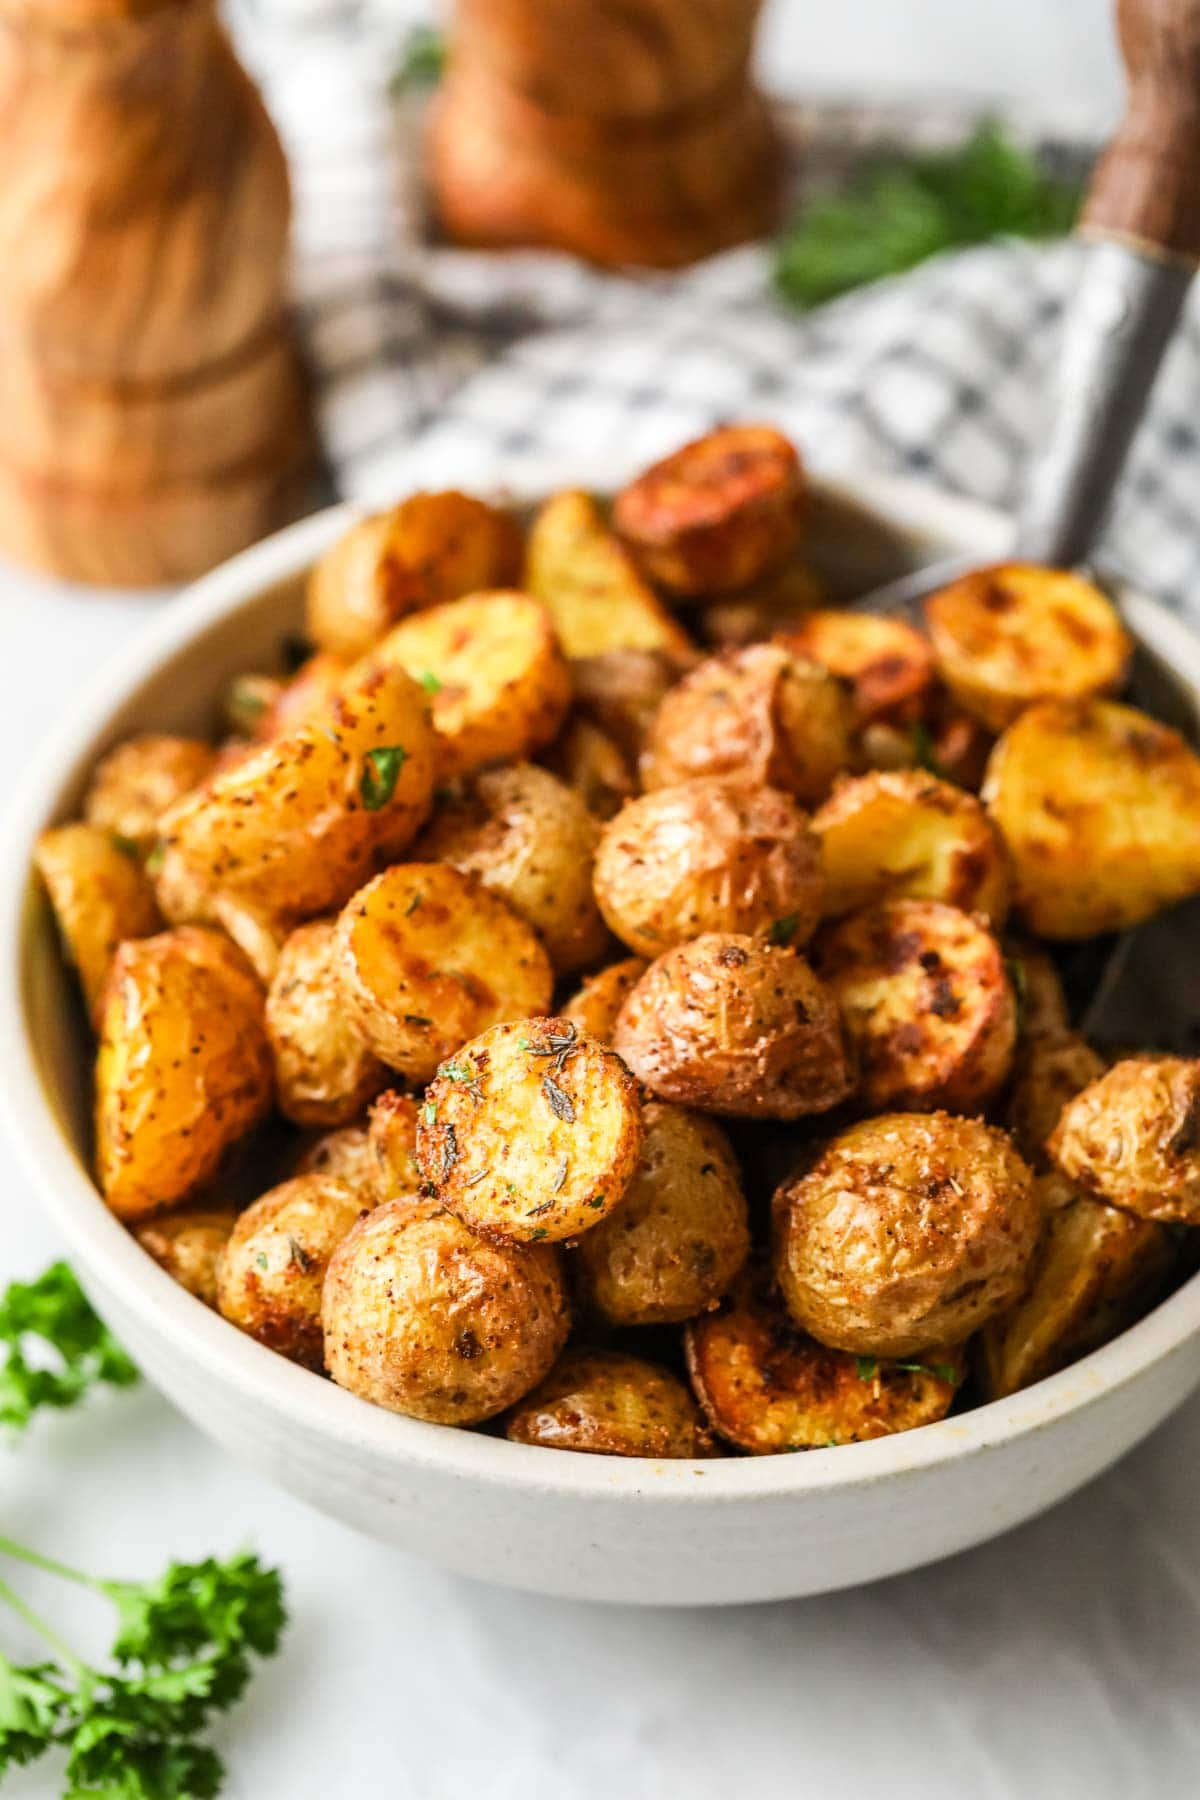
[{"xmin": 813, "ymin": 769, "xmax": 1009, "ymax": 925}]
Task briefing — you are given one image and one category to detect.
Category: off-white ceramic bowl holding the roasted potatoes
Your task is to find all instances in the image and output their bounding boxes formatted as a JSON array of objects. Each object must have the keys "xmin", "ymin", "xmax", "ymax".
[{"xmin": 0, "ymin": 470, "xmax": 1200, "ymax": 1606}]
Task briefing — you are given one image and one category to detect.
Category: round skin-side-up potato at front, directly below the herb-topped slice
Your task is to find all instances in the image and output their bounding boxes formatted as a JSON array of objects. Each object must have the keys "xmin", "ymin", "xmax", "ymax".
[{"xmin": 322, "ymin": 1201, "xmax": 570, "ymax": 1426}]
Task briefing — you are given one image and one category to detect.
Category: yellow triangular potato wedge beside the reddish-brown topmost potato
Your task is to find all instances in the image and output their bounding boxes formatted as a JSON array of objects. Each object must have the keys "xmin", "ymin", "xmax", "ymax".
[{"xmin": 525, "ymin": 490, "xmax": 691, "ymax": 657}]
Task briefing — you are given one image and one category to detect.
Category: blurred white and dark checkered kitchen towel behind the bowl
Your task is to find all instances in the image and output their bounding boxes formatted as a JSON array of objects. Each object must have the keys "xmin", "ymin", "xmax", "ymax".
[{"xmin": 230, "ymin": 0, "xmax": 1200, "ymax": 610}]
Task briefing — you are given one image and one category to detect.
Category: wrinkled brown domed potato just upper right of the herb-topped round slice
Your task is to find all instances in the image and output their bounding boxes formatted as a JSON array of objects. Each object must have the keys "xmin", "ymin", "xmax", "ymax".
[{"xmin": 613, "ymin": 932, "xmax": 853, "ymax": 1120}]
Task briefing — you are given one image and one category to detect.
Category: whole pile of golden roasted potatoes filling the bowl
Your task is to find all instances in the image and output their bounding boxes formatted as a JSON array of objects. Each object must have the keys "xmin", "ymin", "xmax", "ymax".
[{"xmin": 36, "ymin": 425, "xmax": 1200, "ymax": 1458}]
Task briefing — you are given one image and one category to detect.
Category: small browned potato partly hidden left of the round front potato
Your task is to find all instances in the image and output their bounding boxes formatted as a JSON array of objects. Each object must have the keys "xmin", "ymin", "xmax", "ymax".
[{"xmin": 216, "ymin": 1175, "xmax": 371, "ymax": 1368}]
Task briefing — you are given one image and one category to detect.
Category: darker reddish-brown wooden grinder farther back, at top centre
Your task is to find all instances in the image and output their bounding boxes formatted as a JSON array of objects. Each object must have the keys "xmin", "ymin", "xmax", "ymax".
[{"xmin": 430, "ymin": 0, "xmax": 781, "ymax": 268}]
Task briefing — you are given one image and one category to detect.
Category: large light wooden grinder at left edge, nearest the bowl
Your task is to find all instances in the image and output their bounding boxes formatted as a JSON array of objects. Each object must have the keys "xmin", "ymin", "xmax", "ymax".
[{"xmin": 0, "ymin": 0, "xmax": 313, "ymax": 585}]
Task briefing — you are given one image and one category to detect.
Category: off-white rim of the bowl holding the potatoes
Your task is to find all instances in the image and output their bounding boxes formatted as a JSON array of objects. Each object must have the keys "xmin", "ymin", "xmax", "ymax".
[{"xmin": 9, "ymin": 463, "xmax": 1200, "ymax": 1507}]
